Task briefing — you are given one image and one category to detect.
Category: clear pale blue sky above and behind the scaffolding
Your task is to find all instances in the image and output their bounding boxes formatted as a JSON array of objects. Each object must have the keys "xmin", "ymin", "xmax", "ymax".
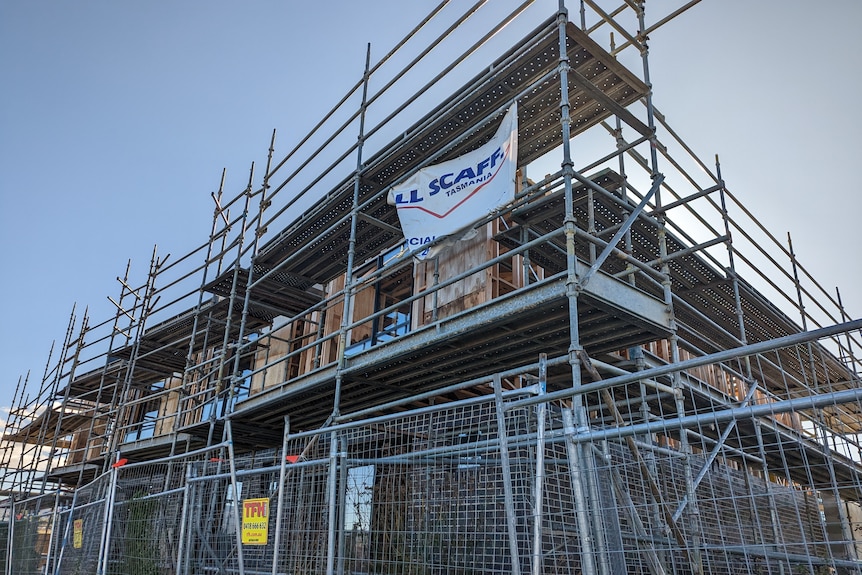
[{"xmin": 0, "ymin": 0, "xmax": 862, "ymax": 420}]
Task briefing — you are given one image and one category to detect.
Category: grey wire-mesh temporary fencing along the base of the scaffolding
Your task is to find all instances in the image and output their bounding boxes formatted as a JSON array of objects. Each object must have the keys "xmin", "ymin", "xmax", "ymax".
[{"xmin": 7, "ymin": 338, "xmax": 862, "ymax": 575}]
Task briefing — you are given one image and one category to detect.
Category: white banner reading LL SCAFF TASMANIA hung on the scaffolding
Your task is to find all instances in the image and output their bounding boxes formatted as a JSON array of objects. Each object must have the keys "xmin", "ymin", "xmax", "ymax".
[{"xmin": 388, "ymin": 104, "xmax": 518, "ymax": 259}]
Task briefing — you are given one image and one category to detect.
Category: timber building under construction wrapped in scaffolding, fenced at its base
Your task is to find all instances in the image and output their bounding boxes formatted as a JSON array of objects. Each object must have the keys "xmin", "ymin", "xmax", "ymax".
[{"xmin": 2, "ymin": 0, "xmax": 862, "ymax": 575}]
